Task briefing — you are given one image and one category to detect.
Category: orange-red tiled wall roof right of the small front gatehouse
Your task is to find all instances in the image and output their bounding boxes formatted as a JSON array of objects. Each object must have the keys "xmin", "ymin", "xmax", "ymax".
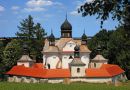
[{"xmin": 86, "ymin": 64, "xmax": 124, "ymax": 77}]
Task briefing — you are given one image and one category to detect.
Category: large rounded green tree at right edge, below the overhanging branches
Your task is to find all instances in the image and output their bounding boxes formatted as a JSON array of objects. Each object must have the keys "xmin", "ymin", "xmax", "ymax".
[{"xmin": 108, "ymin": 27, "xmax": 130, "ymax": 66}]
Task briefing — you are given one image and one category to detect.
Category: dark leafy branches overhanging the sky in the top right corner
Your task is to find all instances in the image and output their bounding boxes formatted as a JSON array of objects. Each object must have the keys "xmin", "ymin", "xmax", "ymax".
[{"xmin": 78, "ymin": 0, "xmax": 130, "ymax": 27}]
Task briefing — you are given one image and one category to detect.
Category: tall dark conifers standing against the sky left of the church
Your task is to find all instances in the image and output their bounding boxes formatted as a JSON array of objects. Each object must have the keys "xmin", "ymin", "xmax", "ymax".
[{"xmin": 16, "ymin": 15, "xmax": 46, "ymax": 59}]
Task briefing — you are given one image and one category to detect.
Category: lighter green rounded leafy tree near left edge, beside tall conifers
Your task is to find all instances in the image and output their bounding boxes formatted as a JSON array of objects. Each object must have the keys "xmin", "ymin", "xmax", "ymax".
[{"xmin": 2, "ymin": 39, "xmax": 22, "ymax": 72}]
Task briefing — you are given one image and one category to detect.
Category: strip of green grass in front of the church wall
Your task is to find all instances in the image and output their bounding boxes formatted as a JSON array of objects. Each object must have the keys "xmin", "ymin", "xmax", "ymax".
[{"xmin": 0, "ymin": 81, "xmax": 130, "ymax": 90}]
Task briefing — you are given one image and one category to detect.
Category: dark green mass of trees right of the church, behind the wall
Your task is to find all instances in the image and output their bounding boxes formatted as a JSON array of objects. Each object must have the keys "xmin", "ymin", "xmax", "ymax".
[{"xmin": 88, "ymin": 27, "xmax": 130, "ymax": 77}]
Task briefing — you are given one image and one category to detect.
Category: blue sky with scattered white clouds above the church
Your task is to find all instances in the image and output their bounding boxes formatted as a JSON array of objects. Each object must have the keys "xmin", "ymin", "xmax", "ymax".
[{"xmin": 0, "ymin": 0, "xmax": 118, "ymax": 37}]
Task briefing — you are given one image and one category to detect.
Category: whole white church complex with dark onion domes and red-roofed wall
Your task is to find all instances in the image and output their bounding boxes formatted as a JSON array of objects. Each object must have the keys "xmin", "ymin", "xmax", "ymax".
[{"xmin": 6, "ymin": 18, "xmax": 125, "ymax": 83}]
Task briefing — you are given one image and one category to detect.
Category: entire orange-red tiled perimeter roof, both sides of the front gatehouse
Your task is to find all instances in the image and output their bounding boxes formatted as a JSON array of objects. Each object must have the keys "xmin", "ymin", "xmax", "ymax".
[{"xmin": 6, "ymin": 63, "xmax": 124, "ymax": 78}]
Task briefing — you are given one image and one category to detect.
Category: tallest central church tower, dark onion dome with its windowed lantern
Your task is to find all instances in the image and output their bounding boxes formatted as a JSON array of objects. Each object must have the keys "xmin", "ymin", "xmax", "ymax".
[{"xmin": 61, "ymin": 15, "xmax": 72, "ymax": 38}]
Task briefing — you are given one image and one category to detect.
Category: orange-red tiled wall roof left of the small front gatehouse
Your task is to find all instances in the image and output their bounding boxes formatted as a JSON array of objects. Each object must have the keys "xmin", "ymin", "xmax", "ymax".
[{"xmin": 6, "ymin": 65, "xmax": 70, "ymax": 78}]
